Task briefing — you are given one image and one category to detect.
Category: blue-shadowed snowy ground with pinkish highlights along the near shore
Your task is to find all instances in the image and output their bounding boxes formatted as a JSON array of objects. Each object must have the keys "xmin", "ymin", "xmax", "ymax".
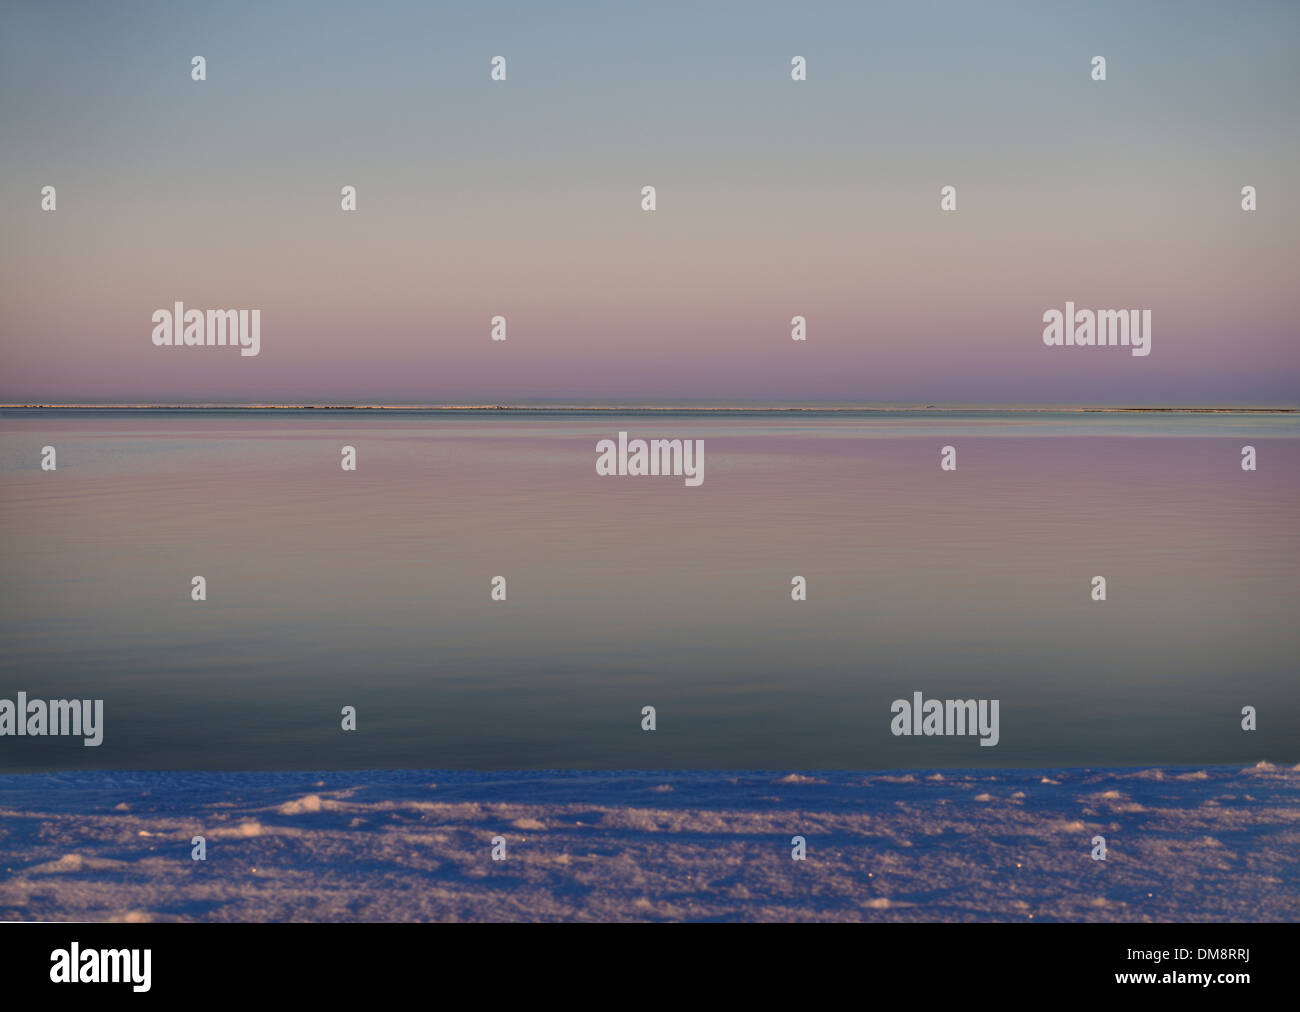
[{"xmin": 0, "ymin": 764, "xmax": 1300, "ymax": 921}]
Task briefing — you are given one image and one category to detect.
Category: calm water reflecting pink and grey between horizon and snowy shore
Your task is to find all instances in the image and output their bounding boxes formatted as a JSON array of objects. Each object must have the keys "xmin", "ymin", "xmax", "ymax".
[{"xmin": 0, "ymin": 411, "xmax": 1300, "ymax": 771}]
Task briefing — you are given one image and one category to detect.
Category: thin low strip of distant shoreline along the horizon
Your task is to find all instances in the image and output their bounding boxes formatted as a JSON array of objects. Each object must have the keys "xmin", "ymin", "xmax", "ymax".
[{"xmin": 0, "ymin": 403, "xmax": 1300, "ymax": 415}]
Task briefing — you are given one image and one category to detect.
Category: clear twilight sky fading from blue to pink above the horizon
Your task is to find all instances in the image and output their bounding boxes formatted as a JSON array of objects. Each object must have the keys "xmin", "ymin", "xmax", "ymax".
[{"xmin": 0, "ymin": 0, "xmax": 1300, "ymax": 406}]
